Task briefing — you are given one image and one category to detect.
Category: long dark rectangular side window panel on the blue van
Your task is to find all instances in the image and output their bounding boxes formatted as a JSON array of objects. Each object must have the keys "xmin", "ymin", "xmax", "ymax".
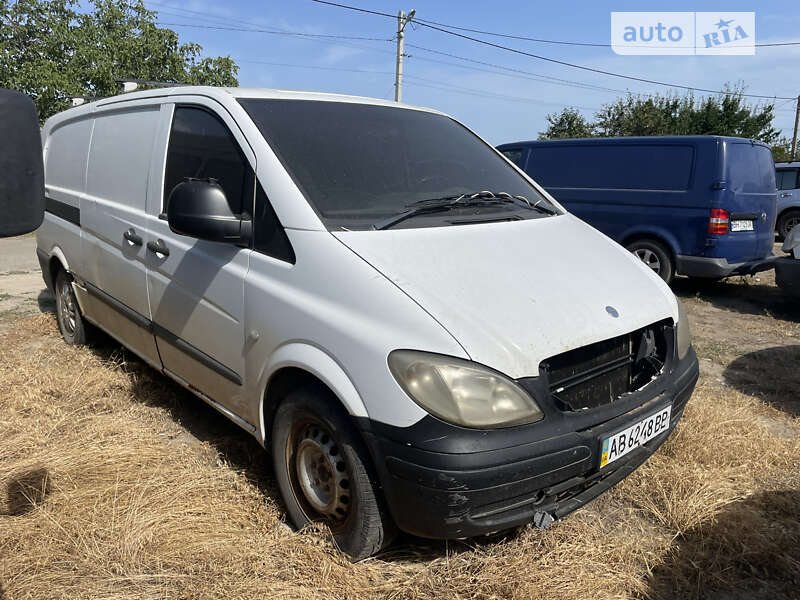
[{"xmin": 528, "ymin": 144, "xmax": 694, "ymax": 190}]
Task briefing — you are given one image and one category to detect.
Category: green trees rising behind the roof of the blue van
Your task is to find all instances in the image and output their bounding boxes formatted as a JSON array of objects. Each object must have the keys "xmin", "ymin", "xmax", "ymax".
[{"xmin": 540, "ymin": 86, "xmax": 780, "ymax": 144}]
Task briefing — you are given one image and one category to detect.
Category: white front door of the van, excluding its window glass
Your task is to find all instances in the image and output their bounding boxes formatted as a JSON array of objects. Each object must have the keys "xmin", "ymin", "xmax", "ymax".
[{"xmin": 146, "ymin": 96, "xmax": 250, "ymax": 416}]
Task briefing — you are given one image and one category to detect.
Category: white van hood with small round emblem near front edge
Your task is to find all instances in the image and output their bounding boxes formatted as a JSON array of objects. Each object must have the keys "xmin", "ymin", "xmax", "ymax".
[{"xmin": 333, "ymin": 214, "xmax": 678, "ymax": 378}]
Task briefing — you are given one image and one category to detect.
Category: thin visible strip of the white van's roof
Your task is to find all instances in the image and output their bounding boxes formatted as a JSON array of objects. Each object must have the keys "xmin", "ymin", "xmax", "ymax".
[{"xmin": 48, "ymin": 85, "xmax": 444, "ymax": 121}]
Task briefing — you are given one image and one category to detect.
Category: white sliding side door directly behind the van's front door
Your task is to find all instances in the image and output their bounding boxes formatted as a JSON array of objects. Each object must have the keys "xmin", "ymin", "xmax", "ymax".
[{"xmin": 81, "ymin": 102, "xmax": 160, "ymax": 365}]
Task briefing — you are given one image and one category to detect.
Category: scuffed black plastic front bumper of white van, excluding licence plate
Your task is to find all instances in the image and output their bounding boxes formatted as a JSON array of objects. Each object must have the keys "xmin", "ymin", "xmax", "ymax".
[{"xmin": 359, "ymin": 350, "xmax": 698, "ymax": 539}]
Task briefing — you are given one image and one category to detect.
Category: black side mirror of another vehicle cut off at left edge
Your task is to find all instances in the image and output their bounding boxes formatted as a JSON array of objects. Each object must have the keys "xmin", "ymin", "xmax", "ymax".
[{"xmin": 0, "ymin": 89, "xmax": 44, "ymax": 237}]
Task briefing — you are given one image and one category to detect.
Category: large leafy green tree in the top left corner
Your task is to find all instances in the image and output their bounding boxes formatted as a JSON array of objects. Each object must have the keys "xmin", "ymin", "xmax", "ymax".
[{"xmin": 0, "ymin": 0, "xmax": 239, "ymax": 120}]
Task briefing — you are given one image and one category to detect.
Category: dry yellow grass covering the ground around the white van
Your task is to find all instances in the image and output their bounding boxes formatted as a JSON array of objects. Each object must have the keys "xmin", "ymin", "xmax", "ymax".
[{"xmin": 0, "ymin": 315, "xmax": 800, "ymax": 600}]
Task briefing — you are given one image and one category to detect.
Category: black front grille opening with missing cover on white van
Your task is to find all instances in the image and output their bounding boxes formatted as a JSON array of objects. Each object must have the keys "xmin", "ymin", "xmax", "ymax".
[{"xmin": 539, "ymin": 322, "xmax": 673, "ymax": 411}]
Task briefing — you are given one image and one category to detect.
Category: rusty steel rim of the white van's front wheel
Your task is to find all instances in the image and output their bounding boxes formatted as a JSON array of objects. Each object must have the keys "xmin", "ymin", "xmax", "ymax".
[{"xmin": 286, "ymin": 416, "xmax": 353, "ymax": 532}]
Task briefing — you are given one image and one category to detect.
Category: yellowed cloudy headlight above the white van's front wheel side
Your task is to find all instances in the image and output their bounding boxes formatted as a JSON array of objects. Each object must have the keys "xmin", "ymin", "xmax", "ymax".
[{"xmin": 389, "ymin": 350, "xmax": 544, "ymax": 427}]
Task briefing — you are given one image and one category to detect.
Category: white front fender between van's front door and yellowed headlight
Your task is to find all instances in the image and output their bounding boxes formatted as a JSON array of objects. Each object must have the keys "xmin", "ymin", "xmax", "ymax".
[{"xmin": 245, "ymin": 230, "xmax": 468, "ymax": 431}]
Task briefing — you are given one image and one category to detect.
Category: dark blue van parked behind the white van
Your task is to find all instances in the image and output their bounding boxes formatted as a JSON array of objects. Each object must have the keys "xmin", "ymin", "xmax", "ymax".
[{"xmin": 498, "ymin": 136, "xmax": 777, "ymax": 282}]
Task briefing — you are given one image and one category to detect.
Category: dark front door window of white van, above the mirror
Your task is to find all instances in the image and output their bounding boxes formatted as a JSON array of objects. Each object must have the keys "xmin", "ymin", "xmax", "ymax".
[{"xmin": 163, "ymin": 106, "xmax": 254, "ymax": 215}]
